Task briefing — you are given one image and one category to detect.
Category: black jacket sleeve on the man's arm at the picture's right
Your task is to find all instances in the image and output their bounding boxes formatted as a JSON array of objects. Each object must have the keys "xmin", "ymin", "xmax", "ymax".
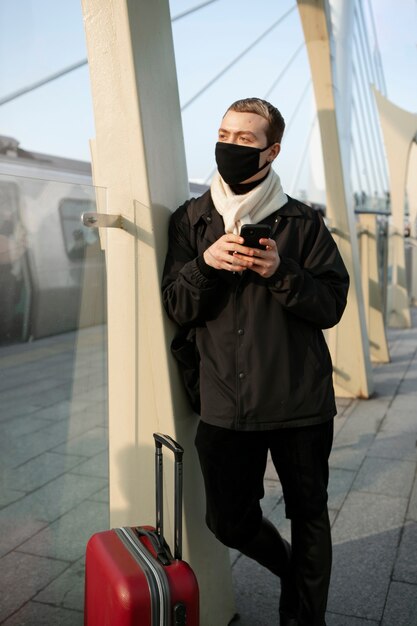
[{"xmin": 268, "ymin": 213, "xmax": 349, "ymax": 329}]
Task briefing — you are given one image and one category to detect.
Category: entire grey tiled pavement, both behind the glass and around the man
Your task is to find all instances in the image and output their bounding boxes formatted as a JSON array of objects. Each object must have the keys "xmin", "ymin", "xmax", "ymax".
[{"xmin": 0, "ymin": 309, "xmax": 417, "ymax": 626}]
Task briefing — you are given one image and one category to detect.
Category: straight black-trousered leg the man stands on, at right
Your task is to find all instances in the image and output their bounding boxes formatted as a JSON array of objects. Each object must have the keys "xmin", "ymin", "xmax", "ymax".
[{"xmin": 270, "ymin": 420, "xmax": 333, "ymax": 626}]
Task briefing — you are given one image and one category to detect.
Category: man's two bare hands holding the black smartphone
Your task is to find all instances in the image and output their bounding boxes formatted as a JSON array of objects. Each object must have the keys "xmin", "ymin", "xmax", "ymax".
[{"xmin": 203, "ymin": 233, "xmax": 280, "ymax": 278}]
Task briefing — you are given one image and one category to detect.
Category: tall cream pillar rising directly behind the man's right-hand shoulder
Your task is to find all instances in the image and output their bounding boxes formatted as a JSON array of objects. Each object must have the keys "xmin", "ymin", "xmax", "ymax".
[{"xmin": 297, "ymin": 0, "xmax": 373, "ymax": 398}]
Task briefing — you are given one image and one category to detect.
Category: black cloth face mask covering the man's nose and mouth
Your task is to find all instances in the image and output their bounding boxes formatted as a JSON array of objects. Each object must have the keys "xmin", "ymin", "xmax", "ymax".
[{"xmin": 216, "ymin": 141, "xmax": 273, "ymax": 185}]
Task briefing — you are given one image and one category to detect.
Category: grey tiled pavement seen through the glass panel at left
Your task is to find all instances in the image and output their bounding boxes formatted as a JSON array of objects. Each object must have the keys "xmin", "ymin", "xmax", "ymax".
[{"xmin": 0, "ymin": 328, "xmax": 108, "ymax": 626}]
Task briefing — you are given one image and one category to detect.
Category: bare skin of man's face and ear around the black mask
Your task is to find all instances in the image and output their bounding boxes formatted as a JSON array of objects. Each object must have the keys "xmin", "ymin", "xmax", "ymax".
[{"xmin": 214, "ymin": 111, "xmax": 280, "ymax": 183}]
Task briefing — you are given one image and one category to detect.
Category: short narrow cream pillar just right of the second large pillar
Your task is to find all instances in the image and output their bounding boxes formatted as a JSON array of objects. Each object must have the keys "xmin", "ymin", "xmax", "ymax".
[{"xmin": 359, "ymin": 213, "xmax": 390, "ymax": 363}]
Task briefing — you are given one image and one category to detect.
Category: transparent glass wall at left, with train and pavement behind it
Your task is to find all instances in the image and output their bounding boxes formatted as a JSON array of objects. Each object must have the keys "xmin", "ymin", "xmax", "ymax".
[{"xmin": 0, "ymin": 172, "xmax": 108, "ymax": 626}]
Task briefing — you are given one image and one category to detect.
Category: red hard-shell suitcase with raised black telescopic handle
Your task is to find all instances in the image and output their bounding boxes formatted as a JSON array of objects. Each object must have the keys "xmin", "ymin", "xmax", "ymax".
[{"xmin": 84, "ymin": 433, "xmax": 199, "ymax": 626}]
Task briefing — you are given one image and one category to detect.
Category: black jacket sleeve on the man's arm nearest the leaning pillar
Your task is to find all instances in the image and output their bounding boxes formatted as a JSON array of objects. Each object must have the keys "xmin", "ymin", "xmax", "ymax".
[{"xmin": 162, "ymin": 203, "xmax": 219, "ymax": 326}]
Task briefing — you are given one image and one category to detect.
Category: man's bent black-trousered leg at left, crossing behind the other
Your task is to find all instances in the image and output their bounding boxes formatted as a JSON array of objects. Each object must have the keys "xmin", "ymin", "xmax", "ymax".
[{"xmin": 196, "ymin": 422, "xmax": 298, "ymax": 626}]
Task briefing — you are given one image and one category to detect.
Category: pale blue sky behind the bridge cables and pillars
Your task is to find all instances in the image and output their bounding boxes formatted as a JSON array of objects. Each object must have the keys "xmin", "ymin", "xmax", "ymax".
[{"xmin": 0, "ymin": 0, "xmax": 417, "ymax": 195}]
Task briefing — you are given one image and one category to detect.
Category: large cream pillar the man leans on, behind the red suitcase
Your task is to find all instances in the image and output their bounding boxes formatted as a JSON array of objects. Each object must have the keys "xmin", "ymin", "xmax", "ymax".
[{"xmin": 82, "ymin": 0, "xmax": 234, "ymax": 626}]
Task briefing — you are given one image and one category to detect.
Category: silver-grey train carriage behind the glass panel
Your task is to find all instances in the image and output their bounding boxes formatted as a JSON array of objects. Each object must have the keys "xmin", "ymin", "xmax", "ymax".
[{"xmin": 0, "ymin": 137, "xmax": 105, "ymax": 344}]
